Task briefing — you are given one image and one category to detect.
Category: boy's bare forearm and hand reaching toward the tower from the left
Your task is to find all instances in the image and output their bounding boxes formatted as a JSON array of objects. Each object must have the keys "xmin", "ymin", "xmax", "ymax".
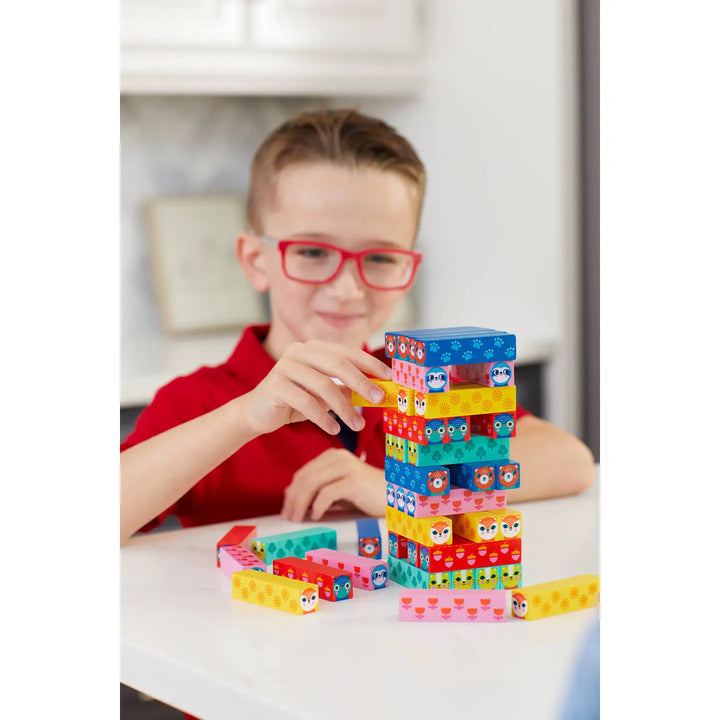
[{"xmin": 120, "ymin": 341, "xmax": 391, "ymax": 543}]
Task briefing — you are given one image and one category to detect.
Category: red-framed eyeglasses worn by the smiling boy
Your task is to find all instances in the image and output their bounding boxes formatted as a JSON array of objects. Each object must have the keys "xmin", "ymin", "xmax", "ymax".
[{"xmin": 261, "ymin": 236, "xmax": 422, "ymax": 290}]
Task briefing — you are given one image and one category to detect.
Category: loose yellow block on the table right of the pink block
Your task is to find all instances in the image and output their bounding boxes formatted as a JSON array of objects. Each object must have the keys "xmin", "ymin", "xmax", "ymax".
[{"xmin": 512, "ymin": 575, "xmax": 600, "ymax": 620}]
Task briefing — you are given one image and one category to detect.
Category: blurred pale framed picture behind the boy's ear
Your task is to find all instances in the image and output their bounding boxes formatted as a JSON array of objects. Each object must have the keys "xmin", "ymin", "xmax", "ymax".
[{"xmin": 147, "ymin": 193, "xmax": 268, "ymax": 334}]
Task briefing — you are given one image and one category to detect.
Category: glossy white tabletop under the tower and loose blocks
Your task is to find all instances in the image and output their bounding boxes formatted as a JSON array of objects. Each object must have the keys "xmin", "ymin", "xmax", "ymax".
[{"xmin": 120, "ymin": 471, "xmax": 599, "ymax": 720}]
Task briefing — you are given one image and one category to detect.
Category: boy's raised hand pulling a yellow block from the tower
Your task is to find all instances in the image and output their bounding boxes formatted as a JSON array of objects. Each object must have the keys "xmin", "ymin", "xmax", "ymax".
[{"xmin": 243, "ymin": 340, "xmax": 392, "ymax": 435}]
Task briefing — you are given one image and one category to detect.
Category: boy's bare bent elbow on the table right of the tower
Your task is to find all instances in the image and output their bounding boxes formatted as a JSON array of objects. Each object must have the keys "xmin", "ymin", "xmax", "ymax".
[{"xmin": 508, "ymin": 415, "xmax": 595, "ymax": 503}]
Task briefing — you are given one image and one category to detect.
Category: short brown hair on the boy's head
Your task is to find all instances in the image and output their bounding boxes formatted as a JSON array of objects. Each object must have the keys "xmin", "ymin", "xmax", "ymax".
[{"xmin": 247, "ymin": 108, "xmax": 426, "ymax": 232}]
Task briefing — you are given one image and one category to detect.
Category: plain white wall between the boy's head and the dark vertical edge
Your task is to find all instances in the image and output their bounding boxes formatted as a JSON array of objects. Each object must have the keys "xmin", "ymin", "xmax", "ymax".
[{"xmin": 334, "ymin": 0, "xmax": 581, "ymax": 433}]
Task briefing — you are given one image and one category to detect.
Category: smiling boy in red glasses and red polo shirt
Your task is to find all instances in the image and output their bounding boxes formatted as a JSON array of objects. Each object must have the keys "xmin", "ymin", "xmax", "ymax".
[{"xmin": 121, "ymin": 110, "xmax": 593, "ymax": 542}]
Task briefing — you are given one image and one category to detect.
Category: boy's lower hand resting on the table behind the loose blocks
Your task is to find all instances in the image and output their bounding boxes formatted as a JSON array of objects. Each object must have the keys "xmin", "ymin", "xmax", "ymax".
[{"xmin": 281, "ymin": 448, "xmax": 385, "ymax": 522}]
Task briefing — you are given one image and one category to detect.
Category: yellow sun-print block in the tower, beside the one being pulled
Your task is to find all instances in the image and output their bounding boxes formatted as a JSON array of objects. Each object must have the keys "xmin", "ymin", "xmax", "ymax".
[{"xmin": 415, "ymin": 383, "xmax": 516, "ymax": 419}]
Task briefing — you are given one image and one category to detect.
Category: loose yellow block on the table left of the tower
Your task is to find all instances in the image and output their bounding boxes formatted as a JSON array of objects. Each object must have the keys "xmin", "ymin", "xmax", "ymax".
[{"xmin": 232, "ymin": 570, "xmax": 319, "ymax": 615}]
